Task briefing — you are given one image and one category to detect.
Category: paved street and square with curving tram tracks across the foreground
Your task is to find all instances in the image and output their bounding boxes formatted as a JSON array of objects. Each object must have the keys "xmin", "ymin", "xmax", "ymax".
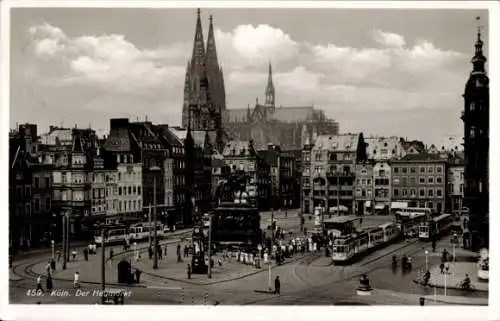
[{"xmin": 10, "ymin": 211, "xmax": 488, "ymax": 305}]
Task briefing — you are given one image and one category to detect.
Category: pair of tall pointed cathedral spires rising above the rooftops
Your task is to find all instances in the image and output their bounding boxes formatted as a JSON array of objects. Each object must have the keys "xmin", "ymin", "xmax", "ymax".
[{"xmin": 182, "ymin": 9, "xmax": 226, "ymax": 149}]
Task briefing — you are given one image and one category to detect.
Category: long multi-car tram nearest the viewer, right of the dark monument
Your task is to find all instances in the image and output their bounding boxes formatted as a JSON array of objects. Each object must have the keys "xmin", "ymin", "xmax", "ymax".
[{"xmin": 332, "ymin": 223, "xmax": 401, "ymax": 265}]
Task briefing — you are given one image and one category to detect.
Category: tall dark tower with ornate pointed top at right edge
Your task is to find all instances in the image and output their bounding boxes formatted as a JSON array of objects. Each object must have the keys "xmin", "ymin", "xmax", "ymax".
[{"xmin": 461, "ymin": 17, "xmax": 490, "ymax": 250}]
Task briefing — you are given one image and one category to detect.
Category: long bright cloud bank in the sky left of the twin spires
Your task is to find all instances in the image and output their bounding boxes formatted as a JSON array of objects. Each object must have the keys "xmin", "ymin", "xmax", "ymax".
[{"xmin": 29, "ymin": 24, "xmax": 187, "ymax": 94}]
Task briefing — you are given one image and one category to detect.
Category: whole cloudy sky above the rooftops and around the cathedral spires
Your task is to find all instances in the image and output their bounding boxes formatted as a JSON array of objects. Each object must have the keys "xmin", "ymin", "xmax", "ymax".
[{"xmin": 10, "ymin": 8, "xmax": 488, "ymax": 143}]
